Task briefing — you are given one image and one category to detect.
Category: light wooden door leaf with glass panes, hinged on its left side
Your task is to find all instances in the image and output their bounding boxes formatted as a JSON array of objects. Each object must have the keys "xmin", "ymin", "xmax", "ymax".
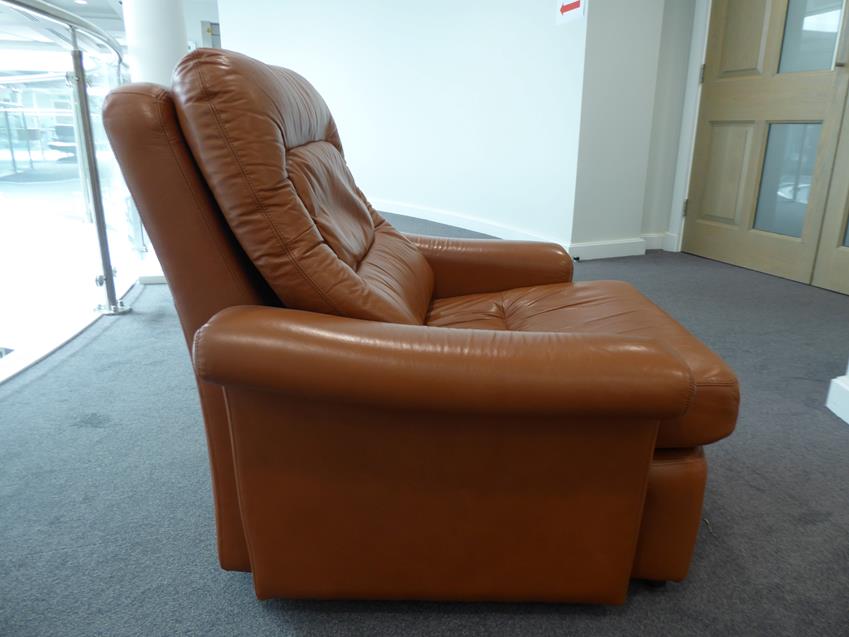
[{"xmin": 683, "ymin": 0, "xmax": 849, "ymax": 283}]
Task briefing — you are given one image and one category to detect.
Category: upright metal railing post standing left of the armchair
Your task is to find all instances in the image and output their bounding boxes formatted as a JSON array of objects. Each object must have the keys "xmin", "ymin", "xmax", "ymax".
[{"xmin": 69, "ymin": 26, "xmax": 130, "ymax": 314}]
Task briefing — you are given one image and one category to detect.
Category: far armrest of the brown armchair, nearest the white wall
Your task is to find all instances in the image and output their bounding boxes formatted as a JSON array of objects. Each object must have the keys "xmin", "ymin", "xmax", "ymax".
[{"xmin": 406, "ymin": 234, "xmax": 572, "ymax": 298}]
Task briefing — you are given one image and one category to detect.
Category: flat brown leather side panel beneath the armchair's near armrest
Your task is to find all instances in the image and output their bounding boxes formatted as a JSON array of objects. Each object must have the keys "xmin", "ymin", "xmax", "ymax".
[{"xmin": 226, "ymin": 388, "xmax": 658, "ymax": 604}]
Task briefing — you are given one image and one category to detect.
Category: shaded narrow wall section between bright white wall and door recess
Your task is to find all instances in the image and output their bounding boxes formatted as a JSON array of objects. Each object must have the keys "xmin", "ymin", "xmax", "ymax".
[{"xmin": 570, "ymin": 0, "xmax": 666, "ymax": 258}]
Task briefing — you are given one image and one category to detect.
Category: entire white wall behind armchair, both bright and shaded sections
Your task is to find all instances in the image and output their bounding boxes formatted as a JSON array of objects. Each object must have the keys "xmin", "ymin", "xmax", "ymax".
[{"xmin": 219, "ymin": 0, "xmax": 706, "ymax": 253}]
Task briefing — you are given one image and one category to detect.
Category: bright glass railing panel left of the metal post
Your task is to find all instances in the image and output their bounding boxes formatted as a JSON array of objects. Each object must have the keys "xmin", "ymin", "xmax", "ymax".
[{"xmin": 0, "ymin": 5, "xmax": 105, "ymax": 380}]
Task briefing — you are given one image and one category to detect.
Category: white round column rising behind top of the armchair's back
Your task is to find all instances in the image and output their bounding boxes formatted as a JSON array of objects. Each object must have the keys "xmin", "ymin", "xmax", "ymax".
[{"xmin": 123, "ymin": 0, "xmax": 187, "ymax": 86}]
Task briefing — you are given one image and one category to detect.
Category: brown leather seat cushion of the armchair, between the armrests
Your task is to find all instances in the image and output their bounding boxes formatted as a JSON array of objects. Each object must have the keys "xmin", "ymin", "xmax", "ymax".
[{"xmin": 426, "ymin": 281, "xmax": 740, "ymax": 448}]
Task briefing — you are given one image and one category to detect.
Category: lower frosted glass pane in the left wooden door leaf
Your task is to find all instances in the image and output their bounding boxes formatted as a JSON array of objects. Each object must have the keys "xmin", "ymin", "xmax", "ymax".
[{"xmin": 755, "ymin": 123, "xmax": 822, "ymax": 237}]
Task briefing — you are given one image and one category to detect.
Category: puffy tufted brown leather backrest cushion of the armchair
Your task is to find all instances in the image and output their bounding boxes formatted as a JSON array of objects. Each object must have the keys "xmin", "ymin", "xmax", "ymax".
[{"xmin": 174, "ymin": 49, "xmax": 433, "ymax": 324}]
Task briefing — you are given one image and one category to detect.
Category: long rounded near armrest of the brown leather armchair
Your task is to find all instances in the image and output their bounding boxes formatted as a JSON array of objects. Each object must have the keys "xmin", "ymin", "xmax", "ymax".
[{"xmin": 193, "ymin": 306, "xmax": 692, "ymax": 419}]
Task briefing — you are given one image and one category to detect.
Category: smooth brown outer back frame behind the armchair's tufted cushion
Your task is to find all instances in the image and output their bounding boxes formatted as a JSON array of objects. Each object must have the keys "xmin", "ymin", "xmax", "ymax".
[{"xmin": 103, "ymin": 84, "xmax": 272, "ymax": 570}]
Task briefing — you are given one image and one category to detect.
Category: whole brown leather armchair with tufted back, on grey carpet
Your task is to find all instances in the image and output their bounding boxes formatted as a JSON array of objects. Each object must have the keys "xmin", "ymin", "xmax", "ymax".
[{"xmin": 104, "ymin": 50, "xmax": 739, "ymax": 603}]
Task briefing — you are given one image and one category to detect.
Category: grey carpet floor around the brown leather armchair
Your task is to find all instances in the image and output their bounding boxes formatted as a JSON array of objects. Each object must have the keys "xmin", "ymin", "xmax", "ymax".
[{"xmin": 0, "ymin": 218, "xmax": 849, "ymax": 637}]
